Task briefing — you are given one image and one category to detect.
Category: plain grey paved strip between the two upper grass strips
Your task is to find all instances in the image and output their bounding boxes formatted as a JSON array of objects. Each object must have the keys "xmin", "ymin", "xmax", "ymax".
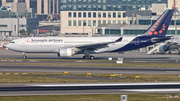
[{"xmin": 0, "ymin": 65, "xmax": 180, "ymax": 75}]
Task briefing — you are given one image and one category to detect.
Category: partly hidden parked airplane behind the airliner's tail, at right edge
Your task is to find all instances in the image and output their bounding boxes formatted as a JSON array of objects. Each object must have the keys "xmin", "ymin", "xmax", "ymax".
[{"xmin": 147, "ymin": 36, "xmax": 180, "ymax": 55}]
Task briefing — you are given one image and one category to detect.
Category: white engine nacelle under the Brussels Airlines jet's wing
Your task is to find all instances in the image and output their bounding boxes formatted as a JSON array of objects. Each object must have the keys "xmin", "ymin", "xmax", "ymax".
[{"xmin": 58, "ymin": 48, "xmax": 75, "ymax": 57}]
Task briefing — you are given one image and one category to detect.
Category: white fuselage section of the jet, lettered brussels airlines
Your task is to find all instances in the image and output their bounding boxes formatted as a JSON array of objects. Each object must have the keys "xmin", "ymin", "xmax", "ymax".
[{"xmin": 6, "ymin": 37, "xmax": 135, "ymax": 53}]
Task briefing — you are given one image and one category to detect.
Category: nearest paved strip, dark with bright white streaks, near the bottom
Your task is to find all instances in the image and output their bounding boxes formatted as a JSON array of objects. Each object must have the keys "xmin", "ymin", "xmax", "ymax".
[{"xmin": 0, "ymin": 82, "xmax": 180, "ymax": 96}]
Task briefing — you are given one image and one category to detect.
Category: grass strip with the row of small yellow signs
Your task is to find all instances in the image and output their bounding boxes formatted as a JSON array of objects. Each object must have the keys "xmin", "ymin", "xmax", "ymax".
[{"xmin": 0, "ymin": 72, "xmax": 180, "ymax": 84}]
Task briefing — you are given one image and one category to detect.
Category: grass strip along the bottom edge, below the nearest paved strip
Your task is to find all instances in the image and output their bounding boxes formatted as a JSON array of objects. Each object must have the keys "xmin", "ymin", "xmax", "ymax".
[{"xmin": 0, "ymin": 94, "xmax": 180, "ymax": 101}]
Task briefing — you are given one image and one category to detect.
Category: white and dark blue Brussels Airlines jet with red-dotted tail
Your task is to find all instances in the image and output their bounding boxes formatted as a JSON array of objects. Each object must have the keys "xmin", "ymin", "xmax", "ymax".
[{"xmin": 6, "ymin": 9, "xmax": 174, "ymax": 59}]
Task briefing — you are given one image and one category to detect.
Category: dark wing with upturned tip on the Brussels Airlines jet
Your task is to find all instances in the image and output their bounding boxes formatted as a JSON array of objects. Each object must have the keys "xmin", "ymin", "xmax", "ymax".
[{"xmin": 75, "ymin": 37, "xmax": 123, "ymax": 51}]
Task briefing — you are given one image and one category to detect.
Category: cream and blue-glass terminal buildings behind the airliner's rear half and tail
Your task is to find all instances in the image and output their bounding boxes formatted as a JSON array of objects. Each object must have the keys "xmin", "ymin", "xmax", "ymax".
[{"xmin": 60, "ymin": 0, "xmax": 180, "ymax": 36}]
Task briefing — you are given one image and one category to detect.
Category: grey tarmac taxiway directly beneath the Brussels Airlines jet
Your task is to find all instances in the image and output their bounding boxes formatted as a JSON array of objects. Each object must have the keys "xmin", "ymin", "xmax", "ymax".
[{"xmin": 0, "ymin": 49, "xmax": 180, "ymax": 61}]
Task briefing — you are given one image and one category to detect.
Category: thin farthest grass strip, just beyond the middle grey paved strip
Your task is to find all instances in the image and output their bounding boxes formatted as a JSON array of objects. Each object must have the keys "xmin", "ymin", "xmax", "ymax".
[{"xmin": 0, "ymin": 63, "xmax": 180, "ymax": 68}]
